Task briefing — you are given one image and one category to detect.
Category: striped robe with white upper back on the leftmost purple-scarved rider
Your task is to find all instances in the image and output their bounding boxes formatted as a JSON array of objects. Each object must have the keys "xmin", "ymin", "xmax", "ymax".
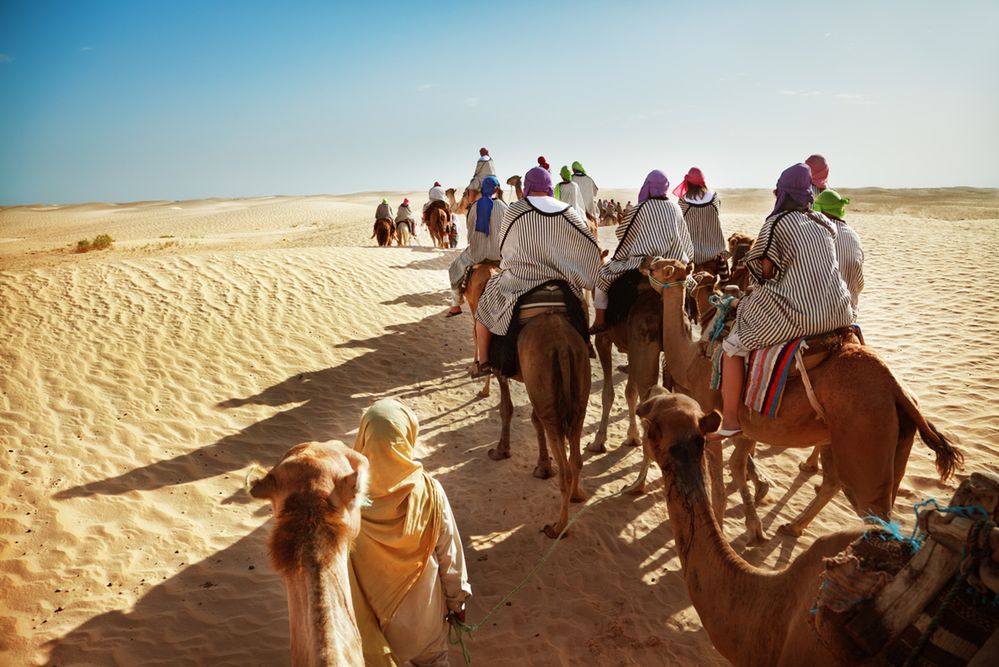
[{"xmin": 476, "ymin": 197, "xmax": 600, "ymax": 336}]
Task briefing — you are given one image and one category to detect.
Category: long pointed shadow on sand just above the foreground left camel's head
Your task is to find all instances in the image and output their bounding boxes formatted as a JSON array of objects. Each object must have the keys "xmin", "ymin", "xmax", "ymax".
[{"xmin": 54, "ymin": 315, "xmax": 467, "ymax": 500}]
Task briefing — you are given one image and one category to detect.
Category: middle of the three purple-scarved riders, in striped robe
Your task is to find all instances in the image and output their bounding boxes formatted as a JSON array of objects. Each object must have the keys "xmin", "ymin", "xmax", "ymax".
[{"xmin": 590, "ymin": 169, "xmax": 694, "ymax": 334}]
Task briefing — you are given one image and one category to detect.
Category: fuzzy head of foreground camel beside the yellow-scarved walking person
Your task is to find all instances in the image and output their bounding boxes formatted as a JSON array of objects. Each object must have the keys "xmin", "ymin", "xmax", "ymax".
[{"xmin": 247, "ymin": 441, "xmax": 368, "ymax": 573}]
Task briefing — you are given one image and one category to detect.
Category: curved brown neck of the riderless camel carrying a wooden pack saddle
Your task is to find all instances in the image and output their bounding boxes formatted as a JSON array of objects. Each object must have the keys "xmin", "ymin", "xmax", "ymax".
[{"xmin": 659, "ymin": 443, "xmax": 783, "ymax": 665}]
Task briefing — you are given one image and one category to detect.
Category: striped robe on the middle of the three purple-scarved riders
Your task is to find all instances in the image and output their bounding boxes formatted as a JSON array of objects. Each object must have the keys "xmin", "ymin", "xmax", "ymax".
[{"xmin": 597, "ymin": 197, "xmax": 694, "ymax": 290}]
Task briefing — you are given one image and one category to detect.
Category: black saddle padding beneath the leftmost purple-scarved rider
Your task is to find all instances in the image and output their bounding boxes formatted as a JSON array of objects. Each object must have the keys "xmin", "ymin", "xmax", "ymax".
[{"xmin": 489, "ymin": 280, "xmax": 590, "ymax": 378}]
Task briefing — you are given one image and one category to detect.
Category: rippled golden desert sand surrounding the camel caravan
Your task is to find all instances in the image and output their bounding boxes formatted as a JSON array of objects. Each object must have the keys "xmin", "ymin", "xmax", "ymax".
[{"xmin": 0, "ymin": 188, "xmax": 999, "ymax": 665}]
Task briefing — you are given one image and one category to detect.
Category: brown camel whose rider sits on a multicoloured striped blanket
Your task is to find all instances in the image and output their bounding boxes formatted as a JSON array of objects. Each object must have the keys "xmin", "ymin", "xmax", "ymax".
[{"xmin": 639, "ymin": 258, "xmax": 963, "ymax": 542}]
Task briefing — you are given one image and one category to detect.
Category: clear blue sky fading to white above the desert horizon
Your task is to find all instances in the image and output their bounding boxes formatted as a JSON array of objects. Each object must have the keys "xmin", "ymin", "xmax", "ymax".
[{"xmin": 0, "ymin": 0, "xmax": 999, "ymax": 205}]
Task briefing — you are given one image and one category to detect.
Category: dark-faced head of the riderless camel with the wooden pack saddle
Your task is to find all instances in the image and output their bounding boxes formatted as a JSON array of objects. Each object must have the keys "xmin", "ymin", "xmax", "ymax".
[{"xmin": 637, "ymin": 392, "xmax": 721, "ymax": 485}]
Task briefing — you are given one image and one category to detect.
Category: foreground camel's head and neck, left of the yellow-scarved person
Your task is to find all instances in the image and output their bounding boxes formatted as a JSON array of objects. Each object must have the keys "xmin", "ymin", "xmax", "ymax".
[{"xmin": 250, "ymin": 442, "xmax": 368, "ymax": 667}]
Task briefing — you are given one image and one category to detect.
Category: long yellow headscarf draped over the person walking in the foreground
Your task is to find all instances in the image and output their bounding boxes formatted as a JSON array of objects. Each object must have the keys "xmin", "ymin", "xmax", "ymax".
[{"xmin": 351, "ymin": 398, "xmax": 443, "ymax": 627}]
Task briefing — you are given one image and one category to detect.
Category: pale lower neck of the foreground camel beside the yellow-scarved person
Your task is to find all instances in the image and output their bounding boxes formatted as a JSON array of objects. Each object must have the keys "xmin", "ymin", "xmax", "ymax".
[{"xmin": 285, "ymin": 540, "xmax": 363, "ymax": 667}]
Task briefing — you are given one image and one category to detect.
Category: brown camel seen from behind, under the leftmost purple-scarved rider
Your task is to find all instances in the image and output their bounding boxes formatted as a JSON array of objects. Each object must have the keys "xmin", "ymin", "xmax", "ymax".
[{"xmin": 489, "ymin": 312, "xmax": 590, "ymax": 538}]
